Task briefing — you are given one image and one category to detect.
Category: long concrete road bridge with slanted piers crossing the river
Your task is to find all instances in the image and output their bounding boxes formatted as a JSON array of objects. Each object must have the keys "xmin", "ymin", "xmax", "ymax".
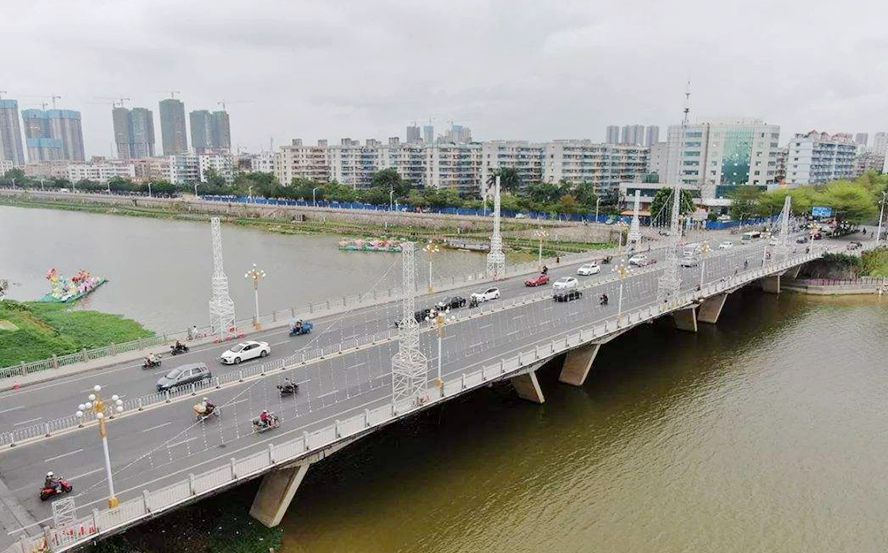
[{"xmin": 0, "ymin": 191, "xmax": 876, "ymax": 553}]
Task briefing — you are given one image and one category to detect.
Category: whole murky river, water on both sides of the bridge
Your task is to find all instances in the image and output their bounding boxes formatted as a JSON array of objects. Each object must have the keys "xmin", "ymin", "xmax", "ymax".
[{"xmin": 0, "ymin": 207, "xmax": 888, "ymax": 553}]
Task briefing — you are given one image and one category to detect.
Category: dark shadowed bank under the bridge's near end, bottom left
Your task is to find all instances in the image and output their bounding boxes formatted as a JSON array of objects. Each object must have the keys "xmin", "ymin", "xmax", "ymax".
[{"xmin": 87, "ymin": 485, "xmax": 284, "ymax": 553}]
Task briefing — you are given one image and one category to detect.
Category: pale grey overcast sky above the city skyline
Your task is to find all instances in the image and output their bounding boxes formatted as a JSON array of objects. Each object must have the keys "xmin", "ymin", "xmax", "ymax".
[{"xmin": 0, "ymin": 0, "xmax": 888, "ymax": 155}]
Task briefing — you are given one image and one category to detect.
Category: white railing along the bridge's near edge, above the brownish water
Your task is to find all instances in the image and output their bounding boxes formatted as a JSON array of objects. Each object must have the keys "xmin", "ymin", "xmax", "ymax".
[{"xmin": 4, "ymin": 250, "xmax": 820, "ymax": 553}]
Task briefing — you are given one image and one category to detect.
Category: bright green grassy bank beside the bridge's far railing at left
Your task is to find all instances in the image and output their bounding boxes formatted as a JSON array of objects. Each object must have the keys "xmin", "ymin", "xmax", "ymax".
[{"xmin": 0, "ymin": 300, "xmax": 153, "ymax": 367}]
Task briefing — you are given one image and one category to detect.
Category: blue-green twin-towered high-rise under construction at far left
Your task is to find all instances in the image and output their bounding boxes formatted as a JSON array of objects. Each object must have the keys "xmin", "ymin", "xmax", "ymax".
[{"xmin": 22, "ymin": 109, "xmax": 85, "ymax": 162}]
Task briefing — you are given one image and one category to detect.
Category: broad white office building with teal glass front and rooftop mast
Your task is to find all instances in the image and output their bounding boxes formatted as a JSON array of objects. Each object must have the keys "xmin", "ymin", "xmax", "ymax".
[{"xmin": 660, "ymin": 119, "xmax": 780, "ymax": 201}]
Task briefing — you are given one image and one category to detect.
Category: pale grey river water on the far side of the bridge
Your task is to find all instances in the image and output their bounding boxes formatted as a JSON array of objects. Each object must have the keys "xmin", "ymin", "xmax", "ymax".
[{"xmin": 0, "ymin": 206, "xmax": 485, "ymax": 331}]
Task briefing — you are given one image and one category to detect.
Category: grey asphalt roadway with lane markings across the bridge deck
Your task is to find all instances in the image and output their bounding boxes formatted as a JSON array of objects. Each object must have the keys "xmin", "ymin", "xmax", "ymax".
[{"xmin": 0, "ymin": 237, "xmax": 800, "ymax": 543}]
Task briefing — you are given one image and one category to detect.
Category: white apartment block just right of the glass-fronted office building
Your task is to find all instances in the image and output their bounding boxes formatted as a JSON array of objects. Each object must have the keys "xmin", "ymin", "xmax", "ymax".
[{"xmin": 786, "ymin": 131, "xmax": 857, "ymax": 184}]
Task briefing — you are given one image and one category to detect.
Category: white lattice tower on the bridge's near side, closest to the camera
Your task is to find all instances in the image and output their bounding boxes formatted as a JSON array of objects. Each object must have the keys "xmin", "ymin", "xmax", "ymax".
[{"xmin": 392, "ymin": 242, "xmax": 429, "ymax": 405}]
